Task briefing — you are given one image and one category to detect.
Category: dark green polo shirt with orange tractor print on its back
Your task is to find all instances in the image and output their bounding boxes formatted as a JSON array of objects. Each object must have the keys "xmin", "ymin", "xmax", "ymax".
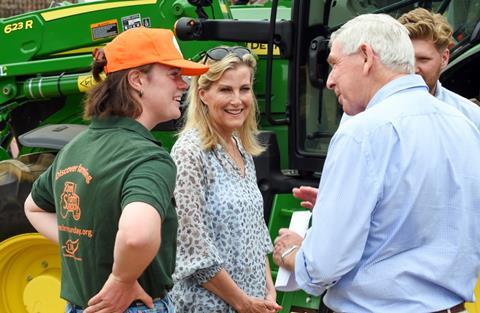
[{"xmin": 32, "ymin": 117, "xmax": 177, "ymax": 307}]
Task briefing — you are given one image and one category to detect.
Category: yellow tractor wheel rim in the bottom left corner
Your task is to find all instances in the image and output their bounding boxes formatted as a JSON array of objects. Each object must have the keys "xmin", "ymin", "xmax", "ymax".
[{"xmin": 0, "ymin": 233, "xmax": 66, "ymax": 313}]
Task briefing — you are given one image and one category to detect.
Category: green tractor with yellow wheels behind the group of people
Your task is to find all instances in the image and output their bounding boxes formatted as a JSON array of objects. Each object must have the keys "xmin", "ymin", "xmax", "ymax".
[{"xmin": 0, "ymin": 0, "xmax": 480, "ymax": 313}]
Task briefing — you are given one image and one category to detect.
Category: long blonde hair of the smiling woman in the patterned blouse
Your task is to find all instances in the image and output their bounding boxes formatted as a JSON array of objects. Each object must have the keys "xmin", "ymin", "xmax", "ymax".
[{"xmin": 180, "ymin": 49, "xmax": 264, "ymax": 156}]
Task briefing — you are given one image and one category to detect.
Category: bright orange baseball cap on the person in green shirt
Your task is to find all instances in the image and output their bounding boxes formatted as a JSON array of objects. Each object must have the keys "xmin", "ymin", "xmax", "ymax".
[{"xmin": 103, "ymin": 27, "xmax": 208, "ymax": 76}]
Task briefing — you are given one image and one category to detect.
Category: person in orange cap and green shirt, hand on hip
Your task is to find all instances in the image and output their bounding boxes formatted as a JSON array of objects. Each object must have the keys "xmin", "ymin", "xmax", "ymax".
[{"xmin": 25, "ymin": 27, "xmax": 208, "ymax": 313}]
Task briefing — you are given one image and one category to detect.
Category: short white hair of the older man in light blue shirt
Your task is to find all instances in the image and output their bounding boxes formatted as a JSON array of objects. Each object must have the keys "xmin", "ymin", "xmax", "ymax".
[{"xmin": 330, "ymin": 14, "xmax": 415, "ymax": 74}]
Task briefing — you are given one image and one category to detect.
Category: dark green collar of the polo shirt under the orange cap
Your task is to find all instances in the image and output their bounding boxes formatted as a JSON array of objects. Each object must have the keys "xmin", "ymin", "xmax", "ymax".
[{"xmin": 90, "ymin": 116, "xmax": 162, "ymax": 145}]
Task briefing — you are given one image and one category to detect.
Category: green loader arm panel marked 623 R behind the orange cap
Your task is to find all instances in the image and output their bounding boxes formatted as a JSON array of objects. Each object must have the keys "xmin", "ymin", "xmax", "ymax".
[{"xmin": 0, "ymin": 0, "xmax": 229, "ymax": 64}]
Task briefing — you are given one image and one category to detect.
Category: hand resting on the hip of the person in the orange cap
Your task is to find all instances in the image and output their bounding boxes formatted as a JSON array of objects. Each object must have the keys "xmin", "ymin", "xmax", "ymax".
[{"xmin": 83, "ymin": 274, "xmax": 153, "ymax": 313}]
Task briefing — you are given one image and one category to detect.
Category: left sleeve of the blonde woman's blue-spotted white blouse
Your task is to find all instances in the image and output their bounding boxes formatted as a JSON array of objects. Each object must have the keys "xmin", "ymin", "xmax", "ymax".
[{"xmin": 172, "ymin": 134, "xmax": 223, "ymax": 284}]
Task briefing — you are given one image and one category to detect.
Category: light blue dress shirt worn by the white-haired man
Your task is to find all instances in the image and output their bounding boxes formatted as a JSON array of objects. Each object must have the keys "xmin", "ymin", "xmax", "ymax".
[{"xmin": 295, "ymin": 75, "xmax": 480, "ymax": 313}]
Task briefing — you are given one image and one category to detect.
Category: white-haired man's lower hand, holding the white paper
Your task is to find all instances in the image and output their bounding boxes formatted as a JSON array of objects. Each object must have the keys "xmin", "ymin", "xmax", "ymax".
[{"xmin": 273, "ymin": 228, "xmax": 303, "ymax": 272}]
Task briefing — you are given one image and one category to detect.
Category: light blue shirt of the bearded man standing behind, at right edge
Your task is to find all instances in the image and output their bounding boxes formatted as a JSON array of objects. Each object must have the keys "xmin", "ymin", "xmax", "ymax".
[{"xmin": 435, "ymin": 81, "xmax": 480, "ymax": 129}]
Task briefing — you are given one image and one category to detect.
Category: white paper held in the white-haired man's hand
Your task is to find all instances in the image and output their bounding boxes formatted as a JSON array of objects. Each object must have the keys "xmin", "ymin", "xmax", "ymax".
[{"xmin": 275, "ymin": 211, "xmax": 312, "ymax": 291}]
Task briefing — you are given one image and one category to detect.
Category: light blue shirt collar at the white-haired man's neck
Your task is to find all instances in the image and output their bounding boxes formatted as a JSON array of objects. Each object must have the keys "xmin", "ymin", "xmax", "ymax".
[{"xmin": 367, "ymin": 74, "xmax": 428, "ymax": 110}]
